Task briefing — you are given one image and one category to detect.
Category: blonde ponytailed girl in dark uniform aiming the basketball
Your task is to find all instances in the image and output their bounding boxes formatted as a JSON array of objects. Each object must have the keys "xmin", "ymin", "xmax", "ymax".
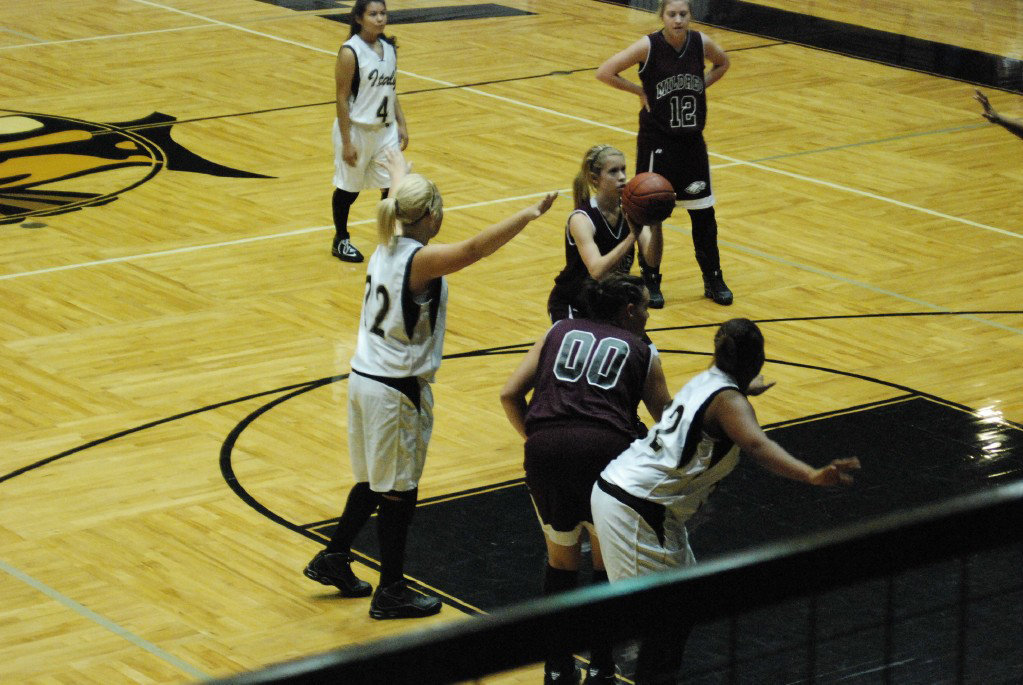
[{"xmin": 547, "ymin": 145, "xmax": 664, "ymax": 322}]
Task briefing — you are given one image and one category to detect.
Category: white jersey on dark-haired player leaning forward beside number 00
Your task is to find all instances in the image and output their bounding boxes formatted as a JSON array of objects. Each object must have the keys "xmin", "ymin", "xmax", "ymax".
[{"xmin": 601, "ymin": 366, "xmax": 739, "ymax": 520}]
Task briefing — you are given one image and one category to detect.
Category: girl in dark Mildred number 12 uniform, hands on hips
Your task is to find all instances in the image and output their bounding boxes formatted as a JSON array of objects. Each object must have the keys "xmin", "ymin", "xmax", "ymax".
[{"xmin": 596, "ymin": 0, "xmax": 732, "ymax": 305}]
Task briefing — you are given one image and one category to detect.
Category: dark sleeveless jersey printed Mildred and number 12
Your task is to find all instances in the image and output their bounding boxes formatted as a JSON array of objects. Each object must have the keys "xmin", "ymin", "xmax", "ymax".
[{"xmin": 639, "ymin": 30, "xmax": 707, "ymax": 136}]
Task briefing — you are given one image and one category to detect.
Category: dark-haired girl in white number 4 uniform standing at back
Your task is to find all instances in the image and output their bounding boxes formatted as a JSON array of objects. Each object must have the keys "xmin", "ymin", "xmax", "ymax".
[{"xmin": 330, "ymin": 0, "xmax": 408, "ymax": 262}]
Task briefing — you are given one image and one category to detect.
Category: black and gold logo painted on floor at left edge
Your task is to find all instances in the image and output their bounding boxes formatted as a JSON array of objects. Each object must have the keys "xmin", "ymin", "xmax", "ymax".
[{"xmin": 0, "ymin": 111, "xmax": 272, "ymax": 224}]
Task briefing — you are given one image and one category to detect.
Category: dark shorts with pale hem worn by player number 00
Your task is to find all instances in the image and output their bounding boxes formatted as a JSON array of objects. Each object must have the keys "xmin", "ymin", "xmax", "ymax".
[{"xmin": 525, "ymin": 423, "xmax": 632, "ymax": 547}]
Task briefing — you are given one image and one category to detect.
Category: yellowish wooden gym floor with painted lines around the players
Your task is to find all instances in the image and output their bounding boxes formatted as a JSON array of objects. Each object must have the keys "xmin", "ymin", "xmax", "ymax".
[{"xmin": 0, "ymin": 0, "xmax": 1023, "ymax": 683}]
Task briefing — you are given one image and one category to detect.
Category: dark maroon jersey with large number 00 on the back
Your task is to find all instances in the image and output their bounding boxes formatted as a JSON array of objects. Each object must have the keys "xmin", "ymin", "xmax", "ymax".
[{"xmin": 526, "ymin": 319, "xmax": 654, "ymax": 437}]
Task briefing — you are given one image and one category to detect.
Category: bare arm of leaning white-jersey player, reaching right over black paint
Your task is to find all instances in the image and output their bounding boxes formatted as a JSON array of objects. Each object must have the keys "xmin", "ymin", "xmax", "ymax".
[{"xmin": 706, "ymin": 391, "xmax": 859, "ymax": 486}]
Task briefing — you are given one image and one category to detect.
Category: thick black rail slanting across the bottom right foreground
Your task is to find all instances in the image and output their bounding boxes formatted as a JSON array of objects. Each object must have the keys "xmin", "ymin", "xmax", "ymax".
[{"xmin": 203, "ymin": 482, "xmax": 1023, "ymax": 685}]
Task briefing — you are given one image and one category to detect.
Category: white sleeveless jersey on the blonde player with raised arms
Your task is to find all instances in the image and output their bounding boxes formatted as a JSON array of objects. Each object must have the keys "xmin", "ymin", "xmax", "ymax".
[{"xmin": 352, "ymin": 237, "xmax": 447, "ymax": 381}]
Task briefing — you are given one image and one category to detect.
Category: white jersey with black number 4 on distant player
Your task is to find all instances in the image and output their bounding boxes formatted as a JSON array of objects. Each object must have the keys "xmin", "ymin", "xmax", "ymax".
[{"xmin": 345, "ymin": 35, "xmax": 398, "ymax": 126}]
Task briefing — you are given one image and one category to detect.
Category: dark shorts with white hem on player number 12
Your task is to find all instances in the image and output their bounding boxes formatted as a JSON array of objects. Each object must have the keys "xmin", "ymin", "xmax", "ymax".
[{"xmin": 636, "ymin": 130, "xmax": 714, "ymax": 210}]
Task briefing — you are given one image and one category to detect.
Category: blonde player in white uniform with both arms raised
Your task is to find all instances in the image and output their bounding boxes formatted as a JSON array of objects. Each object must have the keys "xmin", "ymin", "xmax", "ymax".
[{"xmin": 305, "ymin": 147, "xmax": 558, "ymax": 619}]
